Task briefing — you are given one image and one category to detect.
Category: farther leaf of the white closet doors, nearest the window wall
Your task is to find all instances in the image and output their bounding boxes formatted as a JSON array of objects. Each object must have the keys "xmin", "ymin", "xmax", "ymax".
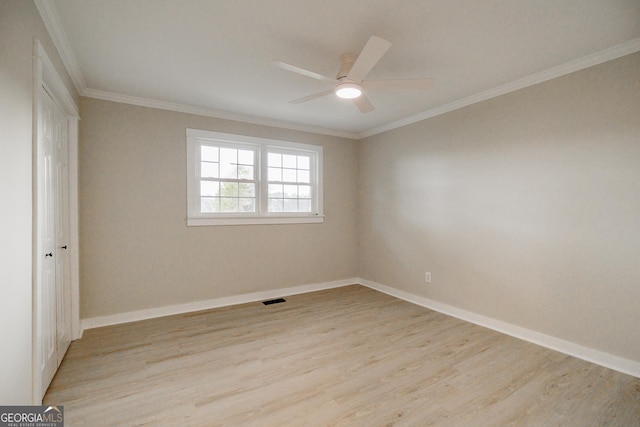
[{"xmin": 53, "ymin": 102, "xmax": 71, "ymax": 366}]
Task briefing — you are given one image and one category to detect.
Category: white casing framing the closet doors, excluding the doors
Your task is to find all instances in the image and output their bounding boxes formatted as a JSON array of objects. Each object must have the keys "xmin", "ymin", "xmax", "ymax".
[{"xmin": 31, "ymin": 39, "xmax": 82, "ymax": 405}]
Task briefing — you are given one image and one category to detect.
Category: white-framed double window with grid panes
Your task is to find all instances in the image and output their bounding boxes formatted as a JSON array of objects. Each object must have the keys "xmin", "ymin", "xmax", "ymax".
[{"xmin": 187, "ymin": 129, "xmax": 323, "ymax": 225}]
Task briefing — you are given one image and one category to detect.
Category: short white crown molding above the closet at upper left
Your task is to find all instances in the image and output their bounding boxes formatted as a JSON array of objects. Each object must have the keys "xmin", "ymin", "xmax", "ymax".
[{"xmin": 35, "ymin": 0, "xmax": 87, "ymax": 94}]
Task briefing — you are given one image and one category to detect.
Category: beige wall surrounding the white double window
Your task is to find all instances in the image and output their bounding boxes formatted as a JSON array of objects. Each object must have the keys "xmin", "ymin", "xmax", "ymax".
[{"xmin": 79, "ymin": 98, "xmax": 357, "ymax": 318}]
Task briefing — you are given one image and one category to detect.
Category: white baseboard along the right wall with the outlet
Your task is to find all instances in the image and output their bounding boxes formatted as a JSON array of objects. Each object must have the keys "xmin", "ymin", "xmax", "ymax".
[{"xmin": 357, "ymin": 278, "xmax": 640, "ymax": 378}]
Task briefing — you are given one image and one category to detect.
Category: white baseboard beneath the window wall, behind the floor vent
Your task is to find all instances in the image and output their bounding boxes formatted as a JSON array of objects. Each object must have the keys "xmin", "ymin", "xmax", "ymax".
[{"xmin": 81, "ymin": 278, "xmax": 358, "ymax": 331}]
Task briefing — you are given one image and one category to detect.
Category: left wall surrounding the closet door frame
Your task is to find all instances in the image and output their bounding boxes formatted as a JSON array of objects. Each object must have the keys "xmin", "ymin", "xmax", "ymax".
[{"xmin": 0, "ymin": 0, "xmax": 75, "ymax": 405}]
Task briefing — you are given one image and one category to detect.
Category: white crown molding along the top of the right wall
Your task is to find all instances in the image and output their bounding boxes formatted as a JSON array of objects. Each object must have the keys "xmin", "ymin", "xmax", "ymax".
[{"xmin": 357, "ymin": 38, "xmax": 640, "ymax": 139}]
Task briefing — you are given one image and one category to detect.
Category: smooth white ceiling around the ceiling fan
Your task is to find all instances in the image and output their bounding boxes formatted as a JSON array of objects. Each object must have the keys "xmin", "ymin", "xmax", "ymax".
[{"xmin": 36, "ymin": 0, "xmax": 640, "ymax": 138}]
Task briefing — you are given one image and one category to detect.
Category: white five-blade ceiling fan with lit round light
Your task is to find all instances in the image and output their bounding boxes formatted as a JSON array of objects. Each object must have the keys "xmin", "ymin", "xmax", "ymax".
[{"xmin": 273, "ymin": 36, "xmax": 434, "ymax": 113}]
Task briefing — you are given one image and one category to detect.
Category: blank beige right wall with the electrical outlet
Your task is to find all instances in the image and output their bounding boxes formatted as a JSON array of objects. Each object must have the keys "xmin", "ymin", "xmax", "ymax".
[{"xmin": 359, "ymin": 54, "xmax": 640, "ymax": 361}]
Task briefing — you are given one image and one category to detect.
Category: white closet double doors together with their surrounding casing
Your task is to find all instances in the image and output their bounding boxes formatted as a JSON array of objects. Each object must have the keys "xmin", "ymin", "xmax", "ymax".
[{"xmin": 32, "ymin": 40, "xmax": 79, "ymax": 405}]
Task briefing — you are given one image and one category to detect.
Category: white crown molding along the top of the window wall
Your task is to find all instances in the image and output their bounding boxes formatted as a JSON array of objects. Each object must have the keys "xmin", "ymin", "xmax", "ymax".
[{"xmin": 82, "ymin": 88, "xmax": 357, "ymax": 139}]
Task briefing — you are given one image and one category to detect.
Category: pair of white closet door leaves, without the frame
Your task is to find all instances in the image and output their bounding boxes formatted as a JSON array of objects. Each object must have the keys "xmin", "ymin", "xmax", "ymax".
[{"xmin": 35, "ymin": 87, "xmax": 71, "ymax": 399}]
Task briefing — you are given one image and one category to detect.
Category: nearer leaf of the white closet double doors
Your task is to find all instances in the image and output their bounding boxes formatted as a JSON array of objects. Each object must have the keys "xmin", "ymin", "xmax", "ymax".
[{"xmin": 35, "ymin": 87, "xmax": 58, "ymax": 398}]
